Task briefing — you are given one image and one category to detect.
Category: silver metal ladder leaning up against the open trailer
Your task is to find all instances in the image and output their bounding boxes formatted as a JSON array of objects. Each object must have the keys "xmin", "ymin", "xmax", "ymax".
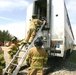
[{"xmin": 3, "ymin": 21, "xmax": 46, "ymax": 75}]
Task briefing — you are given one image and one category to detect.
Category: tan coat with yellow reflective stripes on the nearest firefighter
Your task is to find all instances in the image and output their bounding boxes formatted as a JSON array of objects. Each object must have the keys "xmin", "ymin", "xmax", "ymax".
[{"xmin": 26, "ymin": 47, "xmax": 48, "ymax": 69}]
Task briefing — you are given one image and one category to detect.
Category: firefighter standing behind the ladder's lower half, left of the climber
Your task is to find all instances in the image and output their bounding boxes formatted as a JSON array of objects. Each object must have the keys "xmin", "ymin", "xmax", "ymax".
[{"xmin": 8, "ymin": 36, "xmax": 20, "ymax": 72}]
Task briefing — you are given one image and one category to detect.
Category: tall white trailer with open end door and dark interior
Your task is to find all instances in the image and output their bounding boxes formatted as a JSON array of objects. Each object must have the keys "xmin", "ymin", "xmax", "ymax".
[{"xmin": 26, "ymin": 0, "xmax": 74, "ymax": 57}]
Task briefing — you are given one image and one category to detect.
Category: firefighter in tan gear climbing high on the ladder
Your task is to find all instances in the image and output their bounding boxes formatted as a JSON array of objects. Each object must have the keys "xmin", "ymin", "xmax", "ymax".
[{"xmin": 22, "ymin": 14, "xmax": 43, "ymax": 44}]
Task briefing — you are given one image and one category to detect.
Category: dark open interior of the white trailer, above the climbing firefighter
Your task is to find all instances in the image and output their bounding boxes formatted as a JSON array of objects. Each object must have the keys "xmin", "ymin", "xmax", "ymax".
[{"xmin": 34, "ymin": 0, "xmax": 47, "ymax": 19}]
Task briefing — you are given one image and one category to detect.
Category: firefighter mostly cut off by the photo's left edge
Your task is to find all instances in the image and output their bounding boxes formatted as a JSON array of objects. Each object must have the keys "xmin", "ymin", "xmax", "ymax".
[{"xmin": 0, "ymin": 47, "xmax": 6, "ymax": 75}]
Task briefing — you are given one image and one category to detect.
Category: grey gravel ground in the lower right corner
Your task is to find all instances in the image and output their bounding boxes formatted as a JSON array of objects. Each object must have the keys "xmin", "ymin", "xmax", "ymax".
[{"xmin": 49, "ymin": 58, "xmax": 76, "ymax": 75}]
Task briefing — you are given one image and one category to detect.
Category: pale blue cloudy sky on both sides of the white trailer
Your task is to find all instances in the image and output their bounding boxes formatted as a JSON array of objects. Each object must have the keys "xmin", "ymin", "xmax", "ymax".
[{"xmin": 0, "ymin": 0, "xmax": 76, "ymax": 39}]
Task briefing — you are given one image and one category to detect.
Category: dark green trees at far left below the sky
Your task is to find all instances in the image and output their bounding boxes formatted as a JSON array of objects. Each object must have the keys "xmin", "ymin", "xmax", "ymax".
[{"xmin": 0, "ymin": 30, "xmax": 12, "ymax": 42}]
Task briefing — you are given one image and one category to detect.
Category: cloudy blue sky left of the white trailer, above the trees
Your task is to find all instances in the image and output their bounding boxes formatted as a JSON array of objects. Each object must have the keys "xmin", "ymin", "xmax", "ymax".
[{"xmin": 0, "ymin": 0, "xmax": 33, "ymax": 39}]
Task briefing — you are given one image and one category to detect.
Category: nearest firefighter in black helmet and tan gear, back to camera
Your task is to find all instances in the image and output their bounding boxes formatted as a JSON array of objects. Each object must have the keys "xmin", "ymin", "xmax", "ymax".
[{"xmin": 26, "ymin": 38, "xmax": 47, "ymax": 75}]
